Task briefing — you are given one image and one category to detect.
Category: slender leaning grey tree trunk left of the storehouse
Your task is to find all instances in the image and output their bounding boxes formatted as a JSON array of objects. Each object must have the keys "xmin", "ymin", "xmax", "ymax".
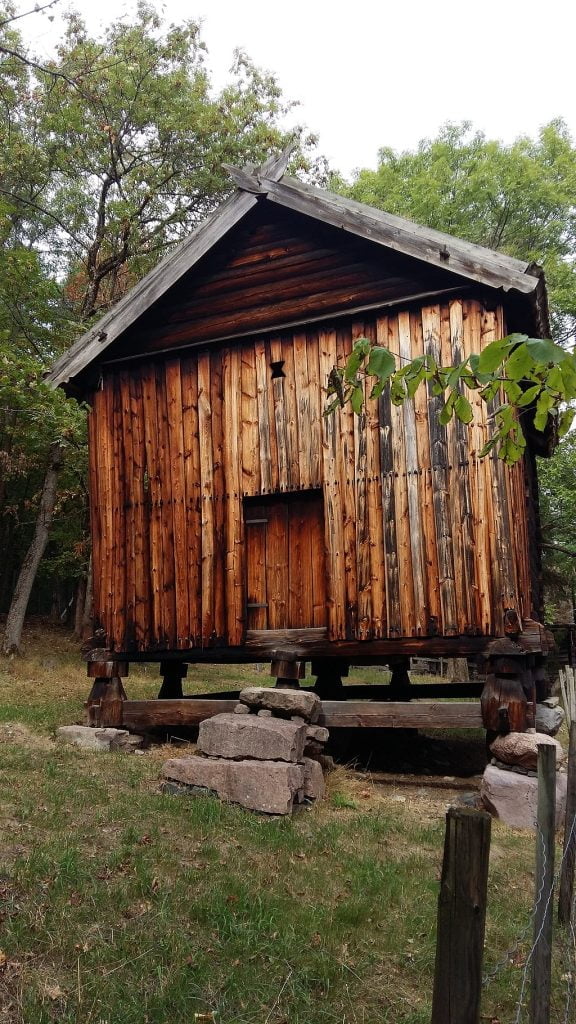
[{"xmin": 4, "ymin": 441, "xmax": 64, "ymax": 654}]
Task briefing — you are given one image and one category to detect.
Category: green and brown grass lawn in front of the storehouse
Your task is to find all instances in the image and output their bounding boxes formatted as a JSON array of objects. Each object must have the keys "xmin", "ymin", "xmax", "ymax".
[{"xmin": 0, "ymin": 627, "xmax": 567, "ymax": 1024}]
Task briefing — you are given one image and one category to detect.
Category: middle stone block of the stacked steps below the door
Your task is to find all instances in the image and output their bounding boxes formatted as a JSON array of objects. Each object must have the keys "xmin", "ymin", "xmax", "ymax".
[{"xmin": 198, "ymin": 714, "xmax": 306, "ymax": 762}]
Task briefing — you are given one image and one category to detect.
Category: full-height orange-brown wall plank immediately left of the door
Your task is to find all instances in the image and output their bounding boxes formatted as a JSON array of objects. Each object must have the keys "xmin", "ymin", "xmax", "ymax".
[{"xmin": 222, "ymin": 348, "xmax": 246, "ymax": 646}]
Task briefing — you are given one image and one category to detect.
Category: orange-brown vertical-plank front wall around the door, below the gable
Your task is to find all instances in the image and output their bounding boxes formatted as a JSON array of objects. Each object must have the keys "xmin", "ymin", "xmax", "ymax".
[{"xmin": 89, "ymin": 299, "xmax": 531, "ymax": 651}]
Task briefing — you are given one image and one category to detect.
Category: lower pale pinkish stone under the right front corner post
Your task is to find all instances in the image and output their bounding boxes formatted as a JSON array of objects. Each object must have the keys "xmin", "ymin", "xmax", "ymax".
[{"xmin": 480, "ymin": 765, "xmax": 567, "ymax": 828}]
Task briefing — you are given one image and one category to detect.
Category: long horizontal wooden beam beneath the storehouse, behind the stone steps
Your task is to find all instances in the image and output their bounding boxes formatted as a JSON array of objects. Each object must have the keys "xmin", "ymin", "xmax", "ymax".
[{"xmin": 116, "ymin": 697, "xmax": 482, "ymax": 732}]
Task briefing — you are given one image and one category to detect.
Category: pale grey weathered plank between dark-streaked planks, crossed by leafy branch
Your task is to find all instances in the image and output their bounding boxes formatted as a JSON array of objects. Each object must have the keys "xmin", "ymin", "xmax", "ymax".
[{"xmin": 398, "ymin": 312, "xmax": 428, "ymax": 636}]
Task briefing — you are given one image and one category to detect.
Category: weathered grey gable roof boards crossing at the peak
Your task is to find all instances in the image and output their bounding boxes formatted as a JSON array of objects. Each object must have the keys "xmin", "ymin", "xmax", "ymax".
[{"xmin": 47, "ymin": 146, "xmax": 549, "ymax": 387}]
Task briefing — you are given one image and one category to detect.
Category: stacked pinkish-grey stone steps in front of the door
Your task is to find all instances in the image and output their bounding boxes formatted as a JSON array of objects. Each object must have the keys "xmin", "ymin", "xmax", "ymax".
[{"xmin": 163, "ymin": 686, "xmax": 328, "ymax": 814}]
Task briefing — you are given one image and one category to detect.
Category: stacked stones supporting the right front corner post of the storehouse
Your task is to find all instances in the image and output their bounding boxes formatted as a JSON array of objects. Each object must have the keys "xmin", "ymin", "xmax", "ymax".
[{"xmin": 481, "ymin": 732, "xmax": 567, "ymax": 828}]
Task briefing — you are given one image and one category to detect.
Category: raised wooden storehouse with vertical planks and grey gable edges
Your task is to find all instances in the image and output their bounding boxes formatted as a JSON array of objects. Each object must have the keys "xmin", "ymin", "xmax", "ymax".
[{"xmin": 51, "ymin": 148, "xmax": 549, "ymax": 733}]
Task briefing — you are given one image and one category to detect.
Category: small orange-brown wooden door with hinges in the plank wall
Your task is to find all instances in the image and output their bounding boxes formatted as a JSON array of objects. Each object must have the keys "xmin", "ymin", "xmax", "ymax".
[{"xmin": 244, "ymin": 492, "xmax": 328, "ymax": 630}]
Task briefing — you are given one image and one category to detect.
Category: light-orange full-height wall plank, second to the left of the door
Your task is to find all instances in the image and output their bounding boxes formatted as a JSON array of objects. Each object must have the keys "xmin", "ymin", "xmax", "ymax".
[{"xmin": 198, "ymin": 352, "xmax": 215, "ymax": 644}]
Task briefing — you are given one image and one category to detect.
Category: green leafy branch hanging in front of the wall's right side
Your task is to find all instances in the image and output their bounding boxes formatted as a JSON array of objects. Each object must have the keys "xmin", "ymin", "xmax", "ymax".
[{"xmin": 326, "ymin": 334, "xmax": 576, "ymax": 465}]
